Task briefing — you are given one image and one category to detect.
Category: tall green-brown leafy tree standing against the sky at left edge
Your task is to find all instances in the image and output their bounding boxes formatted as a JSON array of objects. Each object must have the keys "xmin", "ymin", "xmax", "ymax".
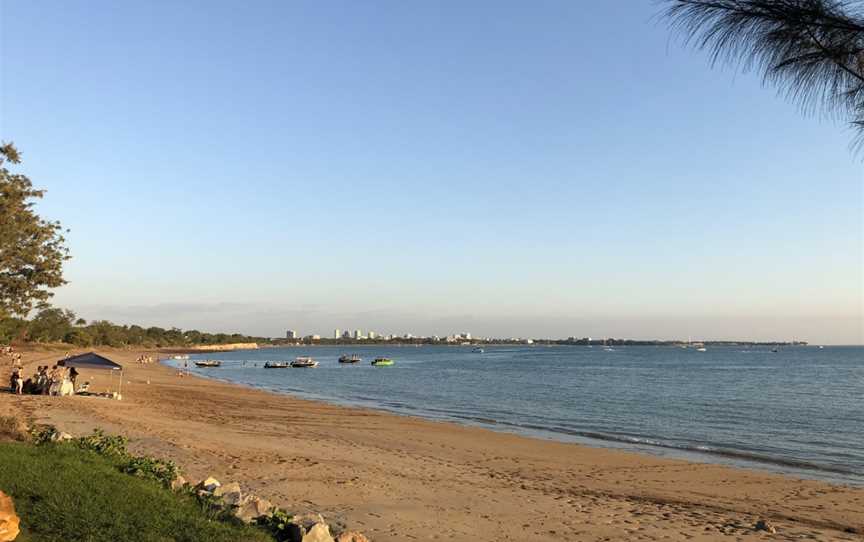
[{"xmin": 0, "ymin": 143, "xmax": 69, "ymax": 316}]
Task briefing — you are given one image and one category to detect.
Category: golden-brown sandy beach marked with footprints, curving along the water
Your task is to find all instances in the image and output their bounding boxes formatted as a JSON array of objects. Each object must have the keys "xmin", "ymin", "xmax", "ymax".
[{"xmin": 0, "ymin": 350, "xmax": 864, "ymax": 542}]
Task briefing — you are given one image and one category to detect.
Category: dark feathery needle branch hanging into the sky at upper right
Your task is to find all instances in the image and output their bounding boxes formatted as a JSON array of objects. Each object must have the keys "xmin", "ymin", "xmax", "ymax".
[{"xmin": 666, "ymin": 0, "xmax": 864, "ymax": 144}]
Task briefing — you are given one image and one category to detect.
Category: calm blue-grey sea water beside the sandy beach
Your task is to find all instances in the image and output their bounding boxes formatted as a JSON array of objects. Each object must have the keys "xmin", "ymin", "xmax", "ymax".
[{"xmin": 170, "ymin": 346, "xmax": 864, "ymax": 485}]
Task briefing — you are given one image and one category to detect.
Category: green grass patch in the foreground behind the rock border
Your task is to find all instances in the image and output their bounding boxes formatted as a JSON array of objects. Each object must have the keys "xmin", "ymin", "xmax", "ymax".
[{"xmin": 0, "ymin": 442, "xmax": 273, "ymax": 542}]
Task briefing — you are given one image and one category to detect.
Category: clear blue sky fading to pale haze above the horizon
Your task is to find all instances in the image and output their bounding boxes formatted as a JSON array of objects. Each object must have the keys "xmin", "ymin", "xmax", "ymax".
[{"xmin": 0, "ymin": 0, "xmax": 864, "ymax": 343}]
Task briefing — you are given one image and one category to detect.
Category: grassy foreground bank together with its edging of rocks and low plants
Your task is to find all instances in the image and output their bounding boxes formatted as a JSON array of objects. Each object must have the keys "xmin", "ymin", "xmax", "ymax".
[{"xmin": 0, "ymin": 415, "xmax": 368, "ymax": 542}]
